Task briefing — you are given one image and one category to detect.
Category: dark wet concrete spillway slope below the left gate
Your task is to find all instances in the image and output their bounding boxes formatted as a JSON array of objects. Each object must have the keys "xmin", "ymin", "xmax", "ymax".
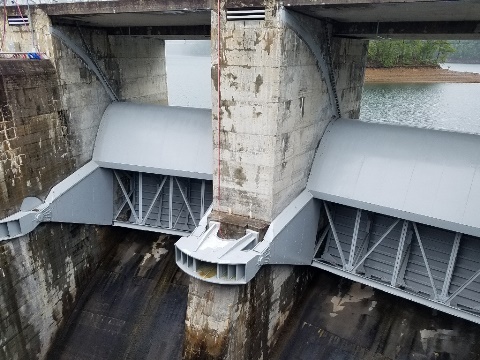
[{"xmin": 49, "ymin": 230, "xmax": 188, "ymax": 360}]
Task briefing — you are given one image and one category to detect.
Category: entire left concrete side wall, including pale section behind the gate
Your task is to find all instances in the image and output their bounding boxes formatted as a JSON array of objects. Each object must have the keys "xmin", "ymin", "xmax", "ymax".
[{"xmin": 0, "ymin": 9, "xmax": 167, "ymax": 360}]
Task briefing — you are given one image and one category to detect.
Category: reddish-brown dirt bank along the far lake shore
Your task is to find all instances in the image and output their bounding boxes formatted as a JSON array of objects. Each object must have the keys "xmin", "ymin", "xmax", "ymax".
[{"xmin": 365, "ymin": 67, "xmax": 480, "ymax": 83}]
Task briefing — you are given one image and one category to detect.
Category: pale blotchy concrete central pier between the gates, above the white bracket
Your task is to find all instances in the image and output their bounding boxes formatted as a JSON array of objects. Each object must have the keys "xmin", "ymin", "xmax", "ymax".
[{"xmin": 212, "ymin": 1, "xmax": 366, "ymax": 221}]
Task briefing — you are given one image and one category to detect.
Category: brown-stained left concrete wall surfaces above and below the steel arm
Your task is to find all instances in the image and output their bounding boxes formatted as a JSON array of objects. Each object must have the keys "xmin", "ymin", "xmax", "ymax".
[{"xmin": 0, "ymin": 60, "xmax": 114, "ymax": 360}]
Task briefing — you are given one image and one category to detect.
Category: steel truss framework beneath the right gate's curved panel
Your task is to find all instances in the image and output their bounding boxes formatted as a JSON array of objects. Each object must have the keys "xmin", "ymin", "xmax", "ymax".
[{"xmin": 312, "ymin": 201, "xmax": 480, "ymax": 323}]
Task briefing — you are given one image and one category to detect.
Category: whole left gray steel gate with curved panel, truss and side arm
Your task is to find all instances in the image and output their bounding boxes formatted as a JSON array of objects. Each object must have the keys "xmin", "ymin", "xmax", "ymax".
[{"xmin": 0, "ymin": 103, "xmax": 213, "ymax": 240}]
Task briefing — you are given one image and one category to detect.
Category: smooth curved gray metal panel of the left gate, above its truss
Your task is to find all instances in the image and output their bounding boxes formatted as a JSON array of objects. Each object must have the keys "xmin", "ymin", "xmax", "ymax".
[{"xmin": 93, "ymin": 103, "xmax": 213, "ymax": 180}]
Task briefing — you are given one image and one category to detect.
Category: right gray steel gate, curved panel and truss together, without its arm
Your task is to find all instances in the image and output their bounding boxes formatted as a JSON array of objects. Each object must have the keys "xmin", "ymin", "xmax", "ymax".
[{"xmin": 307, "ymin": 119, "xmax": 480, "ymax": 323}]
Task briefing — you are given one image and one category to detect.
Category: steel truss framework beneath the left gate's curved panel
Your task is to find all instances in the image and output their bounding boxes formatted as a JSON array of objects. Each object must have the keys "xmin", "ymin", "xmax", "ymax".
[{"xmin": 114, "ymin": 170, "xmax": 212, "ymax": 235}]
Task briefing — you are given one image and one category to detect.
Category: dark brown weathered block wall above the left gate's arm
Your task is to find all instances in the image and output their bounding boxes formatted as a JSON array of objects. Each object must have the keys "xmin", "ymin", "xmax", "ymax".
[{"xmin": 0, "ymin": 60, "xmax": 73, "ymax": 218}]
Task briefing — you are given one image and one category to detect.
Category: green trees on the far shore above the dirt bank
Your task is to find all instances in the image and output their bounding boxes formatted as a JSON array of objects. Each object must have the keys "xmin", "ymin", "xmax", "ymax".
[{"xmin": 368, "ymin": 40, "xmax": 455, "ymax": 67}]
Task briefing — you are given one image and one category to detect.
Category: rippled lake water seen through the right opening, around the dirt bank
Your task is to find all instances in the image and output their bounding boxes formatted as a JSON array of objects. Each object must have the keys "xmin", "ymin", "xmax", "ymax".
[{"xmin": 360, "ymin": 64, "xmax": 480, "ymax": 134}]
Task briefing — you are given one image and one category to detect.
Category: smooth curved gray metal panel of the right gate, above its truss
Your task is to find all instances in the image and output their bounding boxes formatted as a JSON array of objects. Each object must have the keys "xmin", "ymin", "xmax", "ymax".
[{"xmin": 307, "ymin": 119, "xmax": 480, "ymax": 236}]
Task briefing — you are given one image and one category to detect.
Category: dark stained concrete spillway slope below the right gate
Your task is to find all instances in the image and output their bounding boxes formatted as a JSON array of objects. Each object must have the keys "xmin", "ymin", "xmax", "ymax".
[{"xmin": 272, "ymin": 270, "xmax": 480, "ymax": 360}]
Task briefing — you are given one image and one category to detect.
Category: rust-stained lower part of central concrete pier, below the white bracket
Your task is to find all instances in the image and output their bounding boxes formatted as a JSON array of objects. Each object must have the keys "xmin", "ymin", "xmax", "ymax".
[{"xmin": 183, "ymin": 266, "xmax": 316, "ymax": 360}]
